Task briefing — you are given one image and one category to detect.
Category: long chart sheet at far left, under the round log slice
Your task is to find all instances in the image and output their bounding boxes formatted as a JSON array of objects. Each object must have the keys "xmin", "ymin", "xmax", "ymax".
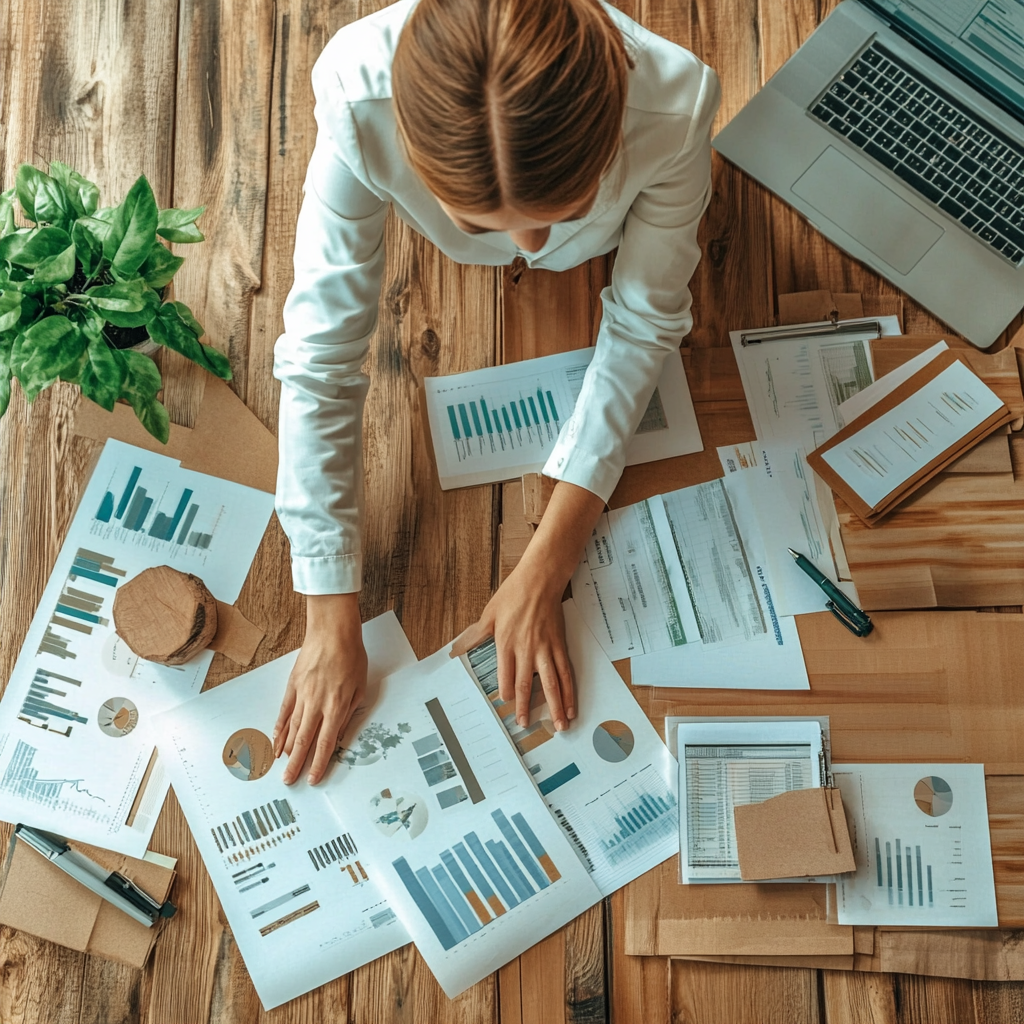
[{"xmin": 0, "ymin": 440, "xmax": 273, "ymax": 857}]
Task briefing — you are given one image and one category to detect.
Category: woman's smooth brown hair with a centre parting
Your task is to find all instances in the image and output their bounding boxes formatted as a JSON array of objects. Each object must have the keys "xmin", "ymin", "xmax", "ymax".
[{"xmin": 391, "ymin": 0, "xmax": 632, "ymax": 213}]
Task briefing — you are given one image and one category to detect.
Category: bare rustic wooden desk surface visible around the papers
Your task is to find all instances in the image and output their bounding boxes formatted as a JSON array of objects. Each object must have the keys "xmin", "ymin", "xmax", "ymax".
[{"xmin": 0, "ymin": 0, "xmax": 1024, "ymax": 1024}]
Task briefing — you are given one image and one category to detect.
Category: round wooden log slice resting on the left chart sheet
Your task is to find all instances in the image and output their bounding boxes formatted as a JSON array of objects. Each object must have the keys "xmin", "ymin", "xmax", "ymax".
[{"xmin": 114, "ymin": 565, "xmax": 217, "ymax": 665}]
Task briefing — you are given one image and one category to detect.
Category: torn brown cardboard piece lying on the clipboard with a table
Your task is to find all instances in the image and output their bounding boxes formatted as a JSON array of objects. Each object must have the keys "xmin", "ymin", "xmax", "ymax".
[{"xmin": 733, "ymin": 786, "xmax": 857, "ymax": 880}]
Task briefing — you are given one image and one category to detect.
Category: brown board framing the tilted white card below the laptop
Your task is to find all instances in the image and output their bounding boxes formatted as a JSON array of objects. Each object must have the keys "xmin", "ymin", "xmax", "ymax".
[{"xmin": 807, "ymin": 351, "xmax": 1014, "ymax": 526}]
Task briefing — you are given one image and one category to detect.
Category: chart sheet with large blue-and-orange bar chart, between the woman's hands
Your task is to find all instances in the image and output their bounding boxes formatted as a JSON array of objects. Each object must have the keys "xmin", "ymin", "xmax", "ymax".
[{"xmin": 326, "ymin": 652, "xmax": 601, "ymax": 997}]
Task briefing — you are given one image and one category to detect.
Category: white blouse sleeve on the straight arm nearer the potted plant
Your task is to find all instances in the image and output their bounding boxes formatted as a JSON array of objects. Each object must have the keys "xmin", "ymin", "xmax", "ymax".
[{"xmin": 273, "ymin": 94, "xmax": 388, "ymax": 594}]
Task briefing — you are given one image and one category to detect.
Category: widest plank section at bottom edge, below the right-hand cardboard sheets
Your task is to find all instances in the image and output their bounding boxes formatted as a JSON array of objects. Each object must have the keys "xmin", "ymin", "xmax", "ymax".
[{"xmin": 671, "ymin": 959, "xmax": 821, "ymax": 1024}]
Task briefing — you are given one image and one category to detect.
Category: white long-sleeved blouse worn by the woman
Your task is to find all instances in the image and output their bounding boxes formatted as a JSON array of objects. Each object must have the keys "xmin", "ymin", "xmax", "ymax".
[{"xmin": 274, "ymin": 0, "xmax": 719, "ymax": 594}]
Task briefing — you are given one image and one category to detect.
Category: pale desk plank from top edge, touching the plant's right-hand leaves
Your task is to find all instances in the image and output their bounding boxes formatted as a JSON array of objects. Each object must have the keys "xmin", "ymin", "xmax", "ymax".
[{"xmin": 164, "ymin": 0, "xmax": 274, "ymax": 426}]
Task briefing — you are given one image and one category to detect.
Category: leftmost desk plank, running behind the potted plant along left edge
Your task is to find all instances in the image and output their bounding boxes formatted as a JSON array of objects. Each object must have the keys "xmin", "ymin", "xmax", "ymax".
[{"xmin": 0, "ymin": 0, "xmax": 177, "ymax": 1022}]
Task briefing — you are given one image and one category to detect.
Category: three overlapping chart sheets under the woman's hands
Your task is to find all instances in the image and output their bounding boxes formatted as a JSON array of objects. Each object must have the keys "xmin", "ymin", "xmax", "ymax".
[{"xmin": 151, "ymin": 605, "xmax": 678, "ymax": 1009}]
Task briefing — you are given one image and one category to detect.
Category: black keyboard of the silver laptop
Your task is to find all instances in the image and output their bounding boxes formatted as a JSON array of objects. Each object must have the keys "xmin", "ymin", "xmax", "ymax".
[{"xmin": 810, "ymin": 43, "xmax": 1024, "ymax": 265}]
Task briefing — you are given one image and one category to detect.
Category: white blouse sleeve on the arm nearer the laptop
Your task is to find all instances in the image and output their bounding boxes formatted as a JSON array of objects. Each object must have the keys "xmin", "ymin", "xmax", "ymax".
[{"xmin": 544, "ymin": 61, "xmax": 720, "ymax": 501}]
